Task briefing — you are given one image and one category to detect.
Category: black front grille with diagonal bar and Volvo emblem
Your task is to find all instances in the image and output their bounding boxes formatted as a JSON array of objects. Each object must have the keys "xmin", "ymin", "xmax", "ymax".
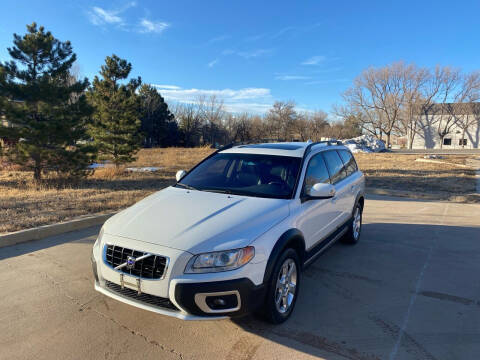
[{"xmin": 105, "ymin": 245, "xmax": 167, "ymax": 279}]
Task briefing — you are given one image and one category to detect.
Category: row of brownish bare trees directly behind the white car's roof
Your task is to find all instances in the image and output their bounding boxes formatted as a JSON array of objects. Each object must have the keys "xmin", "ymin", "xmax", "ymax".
[{"xmin": 172, "ymin": 95, "xmax": 361, "ymax": 147}]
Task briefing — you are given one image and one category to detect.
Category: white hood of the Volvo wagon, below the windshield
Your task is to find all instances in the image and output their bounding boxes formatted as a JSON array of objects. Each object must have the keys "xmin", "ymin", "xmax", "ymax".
[{"xmin": 104, "ymin": 187, "xmax": 289, "ymax": 254}]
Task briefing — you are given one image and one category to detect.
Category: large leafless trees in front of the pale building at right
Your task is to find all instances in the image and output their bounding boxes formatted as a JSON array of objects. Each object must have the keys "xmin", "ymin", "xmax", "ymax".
[{"xmin": 335, "ymin": 62, "xmax": 480, "ymax": 149}]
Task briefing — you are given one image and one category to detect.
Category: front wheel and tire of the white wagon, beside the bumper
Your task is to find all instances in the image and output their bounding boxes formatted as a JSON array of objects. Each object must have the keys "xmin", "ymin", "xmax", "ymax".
[{"xmin": 263, "ymin": 248, "xmax": 301, "ymax": 324}]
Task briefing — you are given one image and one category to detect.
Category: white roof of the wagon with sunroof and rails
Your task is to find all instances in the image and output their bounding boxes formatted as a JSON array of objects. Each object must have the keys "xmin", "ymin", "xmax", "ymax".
[{"xmin": 221, "ymin": 142, "xmax": 346, "ymax": 157}]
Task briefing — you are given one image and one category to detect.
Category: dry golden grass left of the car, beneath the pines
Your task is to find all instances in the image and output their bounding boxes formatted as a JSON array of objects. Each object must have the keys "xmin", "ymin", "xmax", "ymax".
[{"xmin": 0, "ymin": 148, "xmax": 212, "ymax": 234}]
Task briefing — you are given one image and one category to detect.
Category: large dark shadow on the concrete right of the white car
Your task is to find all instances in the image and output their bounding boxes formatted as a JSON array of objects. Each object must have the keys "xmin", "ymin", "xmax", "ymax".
[{"xmin": 232, "ymin": 223, "xmax": 480, "ymax": 360}]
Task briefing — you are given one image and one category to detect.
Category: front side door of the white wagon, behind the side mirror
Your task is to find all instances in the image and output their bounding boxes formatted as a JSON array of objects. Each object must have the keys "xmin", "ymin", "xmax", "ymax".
[{"xmin": 297, "ymin": 153, "xmax": 341, "ymax": 251}]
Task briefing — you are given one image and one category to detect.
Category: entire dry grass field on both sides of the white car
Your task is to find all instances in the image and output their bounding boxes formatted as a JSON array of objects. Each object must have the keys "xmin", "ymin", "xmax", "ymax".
[{"xmin": 0, "ymin": 148, "xmax": 475, "ymax": 233}]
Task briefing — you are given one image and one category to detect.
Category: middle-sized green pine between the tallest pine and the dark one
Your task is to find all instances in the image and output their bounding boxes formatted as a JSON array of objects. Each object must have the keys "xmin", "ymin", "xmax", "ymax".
[{"xmin": 88, "ymin": 55, "xmax": 141, "ymax": 166}]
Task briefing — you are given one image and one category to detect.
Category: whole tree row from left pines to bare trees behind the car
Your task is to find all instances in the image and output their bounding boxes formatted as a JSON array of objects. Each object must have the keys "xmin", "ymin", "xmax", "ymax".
[{"xmin": 0, "ymin": 23, "xmax": 360, "ymax": 181}]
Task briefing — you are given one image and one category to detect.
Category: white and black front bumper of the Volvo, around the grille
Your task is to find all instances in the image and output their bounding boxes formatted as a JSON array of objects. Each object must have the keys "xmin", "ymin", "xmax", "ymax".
[{"xmin": 92, "ymin": 233, "xmax": 265, "ymax": 320}]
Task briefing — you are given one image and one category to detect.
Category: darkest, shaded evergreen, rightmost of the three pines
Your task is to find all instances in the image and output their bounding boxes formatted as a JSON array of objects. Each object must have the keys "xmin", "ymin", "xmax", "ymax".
[{"xmin": 139, "ymin": 84, "xmax": 178, "ymax": 147}]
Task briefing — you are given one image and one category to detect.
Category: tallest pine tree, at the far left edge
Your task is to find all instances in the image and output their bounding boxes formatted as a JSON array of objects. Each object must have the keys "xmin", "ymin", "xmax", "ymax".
[{"xmin": 0, "ymin": 23, "xmax": 94, "ymax": 181}]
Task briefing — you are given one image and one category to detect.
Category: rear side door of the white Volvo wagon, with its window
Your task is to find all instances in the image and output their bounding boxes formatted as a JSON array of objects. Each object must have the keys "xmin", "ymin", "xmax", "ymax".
[{"xmin": 323, "ymin": 150, "xmax": 351, "ymax": 228}]
